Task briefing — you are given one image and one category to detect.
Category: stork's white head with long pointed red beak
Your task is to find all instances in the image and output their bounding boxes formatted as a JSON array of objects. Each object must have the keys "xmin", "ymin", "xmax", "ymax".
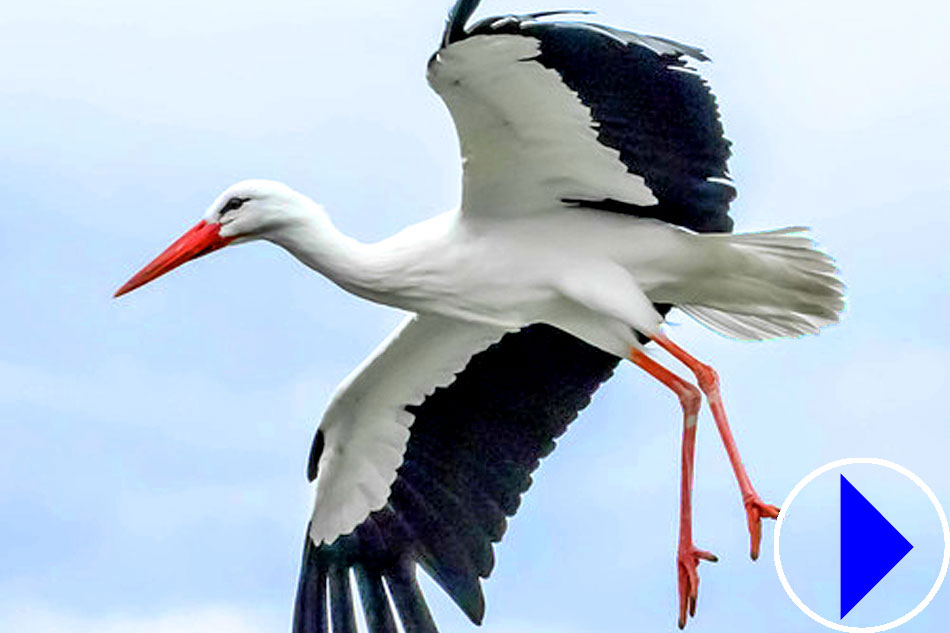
[{"xmin": 115, "ymin": 180, "xmax": 303, "ymax": 297}]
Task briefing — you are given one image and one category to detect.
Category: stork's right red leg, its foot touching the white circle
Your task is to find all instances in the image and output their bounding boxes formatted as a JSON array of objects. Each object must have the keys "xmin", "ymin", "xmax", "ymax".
[{"xmin": 653, "ymin": 334, "xmax": 779, "ymax": 560}]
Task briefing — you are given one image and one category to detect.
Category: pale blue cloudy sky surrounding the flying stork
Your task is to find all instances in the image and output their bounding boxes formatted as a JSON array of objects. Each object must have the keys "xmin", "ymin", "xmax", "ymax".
[{"xmin": 0, "ymin": 0, "xmax": 950, "ymax": 633}]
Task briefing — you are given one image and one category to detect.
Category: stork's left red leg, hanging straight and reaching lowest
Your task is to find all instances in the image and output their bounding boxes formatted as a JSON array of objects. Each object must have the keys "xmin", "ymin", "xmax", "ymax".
[{"xmin": 630, "ymin": 349, "xmax": 717, "ymax": 629}]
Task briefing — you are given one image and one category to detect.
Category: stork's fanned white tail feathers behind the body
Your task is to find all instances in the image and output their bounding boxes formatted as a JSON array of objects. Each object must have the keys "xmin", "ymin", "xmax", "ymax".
[{"xmin": 679, "ymin": 227, "xmax": 845, "ymax": 340}]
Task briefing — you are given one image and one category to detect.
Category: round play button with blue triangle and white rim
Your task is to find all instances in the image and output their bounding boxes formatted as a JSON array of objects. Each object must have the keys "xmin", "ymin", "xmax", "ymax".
[{"xmin": 773, "ymin": 457, "xmax": 950, "ymax": 633}]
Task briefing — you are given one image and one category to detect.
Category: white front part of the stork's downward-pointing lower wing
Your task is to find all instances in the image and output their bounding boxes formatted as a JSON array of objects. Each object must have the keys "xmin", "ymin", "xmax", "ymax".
[{"xmin": 310, "ymin": 315, "xmax": 505, "ymax": 544}]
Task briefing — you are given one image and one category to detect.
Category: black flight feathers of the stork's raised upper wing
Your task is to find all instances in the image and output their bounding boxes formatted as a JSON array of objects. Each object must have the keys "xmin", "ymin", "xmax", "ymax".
[{"xmin": 526, "ymin": 24, "xmax": 736, "ymax": 232}]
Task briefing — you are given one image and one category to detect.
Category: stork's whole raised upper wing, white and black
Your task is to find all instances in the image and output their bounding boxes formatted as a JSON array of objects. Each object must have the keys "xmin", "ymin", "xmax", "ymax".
[{"xmin": 429, "ymin": 0, "xmax": 735, "ymax": 231}]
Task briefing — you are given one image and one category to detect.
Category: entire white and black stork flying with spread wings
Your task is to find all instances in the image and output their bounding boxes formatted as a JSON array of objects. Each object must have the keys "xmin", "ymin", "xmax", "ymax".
[{"xmin": 116, "ymin": 0, "xmax": 843, "ymax": 633}]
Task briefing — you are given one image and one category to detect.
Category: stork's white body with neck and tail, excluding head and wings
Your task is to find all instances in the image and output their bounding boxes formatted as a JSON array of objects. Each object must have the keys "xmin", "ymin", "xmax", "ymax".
[{"xmin": 264, "ymin": 194, "xmax": 842, "ymax": 356}]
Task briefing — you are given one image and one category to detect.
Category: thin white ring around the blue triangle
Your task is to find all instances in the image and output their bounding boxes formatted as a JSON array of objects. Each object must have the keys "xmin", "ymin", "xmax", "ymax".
[{"xmin": 772, "ymin": 457, "xmax": 950, "ymax": 633}]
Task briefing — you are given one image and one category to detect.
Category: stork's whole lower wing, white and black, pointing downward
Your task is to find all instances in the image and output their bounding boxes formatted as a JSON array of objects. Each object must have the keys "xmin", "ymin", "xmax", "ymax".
[{"xmin": 294, "ymin": 315, "xmax": 618, "ymax": 633}]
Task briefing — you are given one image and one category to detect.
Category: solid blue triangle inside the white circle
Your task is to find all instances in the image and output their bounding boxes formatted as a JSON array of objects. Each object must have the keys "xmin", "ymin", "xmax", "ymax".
[{"xmin": 841, "ymin": 475, "xmax": 914, "ymax": 618}]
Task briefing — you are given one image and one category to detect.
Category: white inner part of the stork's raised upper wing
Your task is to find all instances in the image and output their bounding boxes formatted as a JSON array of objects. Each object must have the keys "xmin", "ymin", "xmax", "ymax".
[{"xmin": 429, "ymin": 35, "xmax": 657, "ymax": 214}]
